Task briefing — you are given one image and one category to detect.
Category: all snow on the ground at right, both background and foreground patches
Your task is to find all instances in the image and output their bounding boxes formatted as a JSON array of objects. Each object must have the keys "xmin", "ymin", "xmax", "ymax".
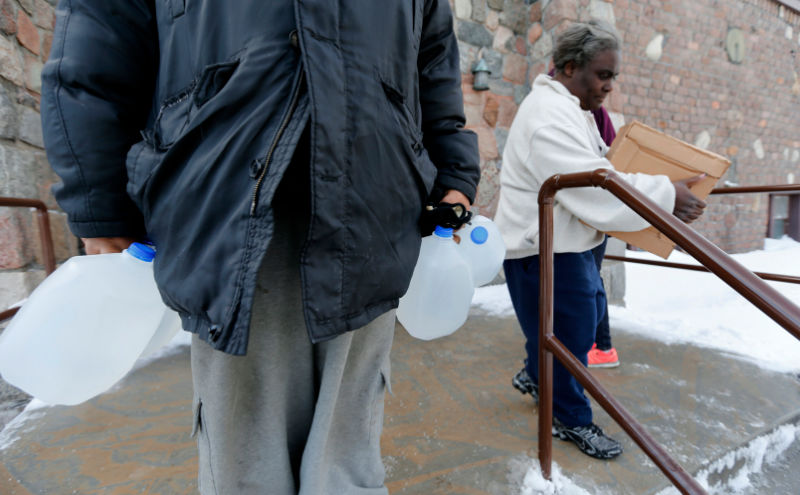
[{"xmin": 472, "ymin": 237, "xmax": 800, "ymax": 495}]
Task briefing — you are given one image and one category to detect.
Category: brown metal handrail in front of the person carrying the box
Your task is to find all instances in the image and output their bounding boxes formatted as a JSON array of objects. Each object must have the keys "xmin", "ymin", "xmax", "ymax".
[{"xmin": 539, "ymin": 169, "xmax": 800, "ymax": 495}]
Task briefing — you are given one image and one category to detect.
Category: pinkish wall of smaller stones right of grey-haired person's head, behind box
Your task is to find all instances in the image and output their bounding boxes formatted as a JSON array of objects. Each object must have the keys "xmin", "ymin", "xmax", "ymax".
[{"xmin": 612, "ymin": 0, "xmax": 800, "ymax": 252}]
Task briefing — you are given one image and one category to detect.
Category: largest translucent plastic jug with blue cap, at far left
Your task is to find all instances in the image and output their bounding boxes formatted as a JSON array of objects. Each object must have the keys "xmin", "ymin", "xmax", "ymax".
[{"xmin": 0, "ymin": 243, "xmax": 177, "ymax": 405}]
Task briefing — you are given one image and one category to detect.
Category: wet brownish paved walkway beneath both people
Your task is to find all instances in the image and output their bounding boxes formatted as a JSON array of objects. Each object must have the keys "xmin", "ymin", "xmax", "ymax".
[{"xmin": 0, "ymin": 314, "xmax": 800, "ymax": 495}]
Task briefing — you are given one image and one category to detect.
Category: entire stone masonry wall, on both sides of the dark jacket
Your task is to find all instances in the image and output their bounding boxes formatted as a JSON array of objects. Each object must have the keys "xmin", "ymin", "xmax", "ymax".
[{"xmin": 0, "ymin": 0, "xmax": 800, "ymax": 309}]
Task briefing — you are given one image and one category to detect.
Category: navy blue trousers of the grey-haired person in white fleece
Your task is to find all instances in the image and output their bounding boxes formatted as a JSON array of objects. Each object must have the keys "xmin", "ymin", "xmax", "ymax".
[{"xmin": 503, "ymin": 250, "xmax": 606, "ymax": 427}]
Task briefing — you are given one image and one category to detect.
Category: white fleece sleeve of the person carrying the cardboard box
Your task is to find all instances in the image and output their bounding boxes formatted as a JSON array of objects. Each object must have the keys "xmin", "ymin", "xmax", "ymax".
[{"xmin": 528, "ymin": 125, "xmax": 675, "ymax": 232}]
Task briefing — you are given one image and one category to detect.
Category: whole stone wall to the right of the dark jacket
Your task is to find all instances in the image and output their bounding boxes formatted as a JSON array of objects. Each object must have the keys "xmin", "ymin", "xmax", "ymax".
[{"xmin": 460, "ymin": 0, "xmax": 800, "ymax": 253}]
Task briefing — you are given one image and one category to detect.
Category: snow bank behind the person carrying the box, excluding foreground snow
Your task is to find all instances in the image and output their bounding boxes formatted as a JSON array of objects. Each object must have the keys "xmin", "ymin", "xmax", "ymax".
[{"xmin": 472, "ymin": 237, "xmax": 800, "ymax": 372}]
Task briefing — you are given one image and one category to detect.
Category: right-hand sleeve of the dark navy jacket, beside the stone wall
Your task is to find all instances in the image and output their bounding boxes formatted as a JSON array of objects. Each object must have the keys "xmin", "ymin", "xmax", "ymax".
[{"xmin": 417, "ymin": 0, "xmax": 480, "ymax": 201}]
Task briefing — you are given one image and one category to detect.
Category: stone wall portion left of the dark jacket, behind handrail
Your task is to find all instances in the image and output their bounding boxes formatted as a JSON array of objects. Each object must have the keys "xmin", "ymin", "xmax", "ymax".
[{"xmin": 0, "ymin": 0, "xmax": 78, "ymax": 310}]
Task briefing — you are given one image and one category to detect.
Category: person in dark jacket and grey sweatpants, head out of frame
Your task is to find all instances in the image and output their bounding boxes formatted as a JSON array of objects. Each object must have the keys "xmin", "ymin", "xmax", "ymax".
[{"xmin": 42, "ymin": 0, "xmax": 479, "ymax": 494}]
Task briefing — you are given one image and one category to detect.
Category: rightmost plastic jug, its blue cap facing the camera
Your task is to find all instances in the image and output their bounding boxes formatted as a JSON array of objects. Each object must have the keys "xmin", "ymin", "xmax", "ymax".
[{"xmin": 456, "ymin": 215, "xmax": 506, "ymax": 287}]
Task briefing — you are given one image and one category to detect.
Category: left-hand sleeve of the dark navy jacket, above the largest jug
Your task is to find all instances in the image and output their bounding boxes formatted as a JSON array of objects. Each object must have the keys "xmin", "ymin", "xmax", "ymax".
[{"xmin": 41, "ymin": 0, "xmax": 158, "ymax": 237}]
